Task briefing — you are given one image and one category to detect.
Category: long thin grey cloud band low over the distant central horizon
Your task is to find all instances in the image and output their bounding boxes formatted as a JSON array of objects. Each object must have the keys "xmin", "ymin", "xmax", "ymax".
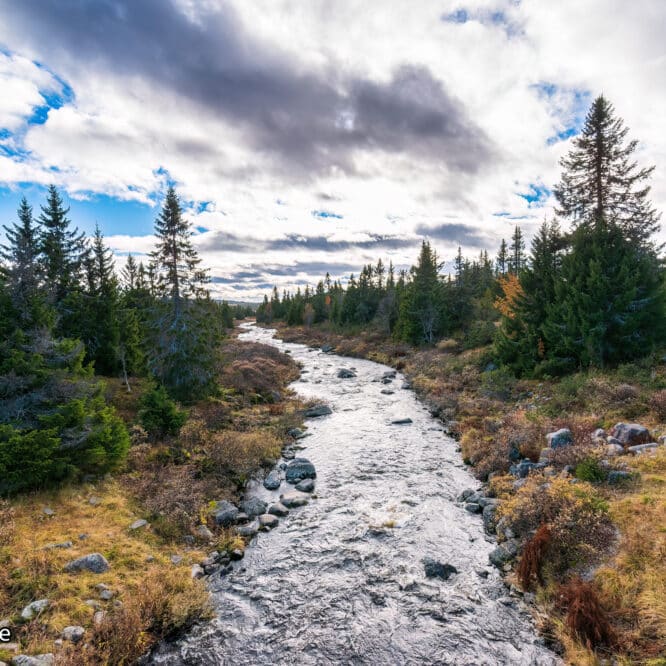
[{"xmin": 198, "ymin": 231, "xmax": 418, "ymax": 254}]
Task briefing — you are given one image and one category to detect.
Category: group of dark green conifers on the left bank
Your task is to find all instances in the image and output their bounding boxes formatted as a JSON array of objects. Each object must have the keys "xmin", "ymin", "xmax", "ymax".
[{"xmin": 0, "ymin": 186, "xmax": 239, "ymax": 495}]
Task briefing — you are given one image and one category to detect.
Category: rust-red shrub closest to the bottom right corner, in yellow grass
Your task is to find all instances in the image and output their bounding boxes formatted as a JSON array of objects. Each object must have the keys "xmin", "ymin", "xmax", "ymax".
[{"xmin": 557, "ymin": 578, "xmax": 616, "ymax": 650}]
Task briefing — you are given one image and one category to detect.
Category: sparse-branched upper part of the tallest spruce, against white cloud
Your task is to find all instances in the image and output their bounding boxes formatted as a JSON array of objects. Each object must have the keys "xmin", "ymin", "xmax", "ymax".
[{"xmin": 554, "ymin": 95, "xmax": 660, "ymax": 246}]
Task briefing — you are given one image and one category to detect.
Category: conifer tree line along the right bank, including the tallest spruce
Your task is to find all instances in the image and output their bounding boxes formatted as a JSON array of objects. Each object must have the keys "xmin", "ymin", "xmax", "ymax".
[{"xmin": 257, "ymin": 96, "xmax": 666, "ymax": 376}]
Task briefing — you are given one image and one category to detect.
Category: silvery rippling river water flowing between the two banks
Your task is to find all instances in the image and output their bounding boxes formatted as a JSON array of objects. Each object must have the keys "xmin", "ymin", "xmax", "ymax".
[{"xmin": 150, "ymin": 326, "xmax": 561, "ymax": 666}]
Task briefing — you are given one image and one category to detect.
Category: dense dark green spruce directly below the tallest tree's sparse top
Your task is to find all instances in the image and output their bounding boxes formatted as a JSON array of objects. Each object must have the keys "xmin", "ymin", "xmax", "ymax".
[{"xmin": 543, "ymin": 219, "xmax": 666, "ymax": 372}]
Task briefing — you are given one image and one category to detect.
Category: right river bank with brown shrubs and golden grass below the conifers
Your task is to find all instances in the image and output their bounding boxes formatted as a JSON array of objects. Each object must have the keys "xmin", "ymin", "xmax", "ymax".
[{"xmin": 268, "ymin": 325, "xmax": 666, "ymax": 665}]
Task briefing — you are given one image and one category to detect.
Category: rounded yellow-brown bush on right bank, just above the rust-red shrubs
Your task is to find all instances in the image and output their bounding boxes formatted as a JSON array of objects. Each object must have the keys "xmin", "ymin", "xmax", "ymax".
[{"xmin": 498, "ymin": 475, "xmax": 615, "ymax": 579}]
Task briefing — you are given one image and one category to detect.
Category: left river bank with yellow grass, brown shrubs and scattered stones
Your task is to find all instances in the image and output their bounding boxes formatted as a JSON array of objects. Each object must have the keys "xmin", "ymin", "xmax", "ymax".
[{"xmin": 0, "ymin": 339, "xmax": 303, "ymax": 666}]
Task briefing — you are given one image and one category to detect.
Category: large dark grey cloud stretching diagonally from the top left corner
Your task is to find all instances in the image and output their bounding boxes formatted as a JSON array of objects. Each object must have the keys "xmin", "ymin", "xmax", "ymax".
[{"xmin": 0, "ymin": 0, "xmax": 493, "ymax": 176}]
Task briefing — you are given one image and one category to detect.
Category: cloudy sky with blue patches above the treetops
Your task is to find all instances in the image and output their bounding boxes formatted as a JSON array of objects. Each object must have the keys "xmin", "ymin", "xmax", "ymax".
[{"xmin": 0, "ymin": 0, "xmax": 666, "ymax": 301}]
